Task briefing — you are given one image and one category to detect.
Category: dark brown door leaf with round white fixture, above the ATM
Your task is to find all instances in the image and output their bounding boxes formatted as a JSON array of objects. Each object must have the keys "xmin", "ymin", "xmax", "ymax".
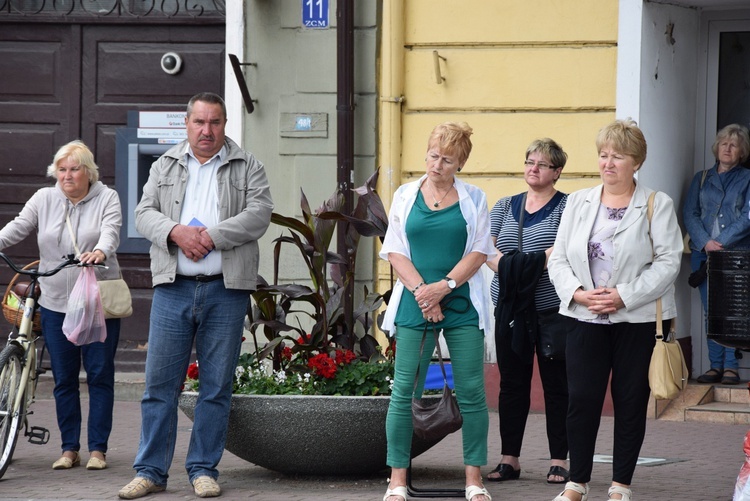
[{"xmin": 81, "ymin": 25, "xmax": 224, "ymax": 184}]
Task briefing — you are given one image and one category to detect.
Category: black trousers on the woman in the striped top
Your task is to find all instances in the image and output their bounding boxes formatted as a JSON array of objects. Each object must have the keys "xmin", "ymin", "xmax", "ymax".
[{"xmin": 495, "ymin": 316, "xmax": 570, "ymax": 460}]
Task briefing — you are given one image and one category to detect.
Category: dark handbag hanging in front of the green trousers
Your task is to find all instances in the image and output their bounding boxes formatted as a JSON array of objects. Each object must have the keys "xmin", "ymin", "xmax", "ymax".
[{"xmin": 411, "ymin": 324, "xmax": 464, "ymax": 442}]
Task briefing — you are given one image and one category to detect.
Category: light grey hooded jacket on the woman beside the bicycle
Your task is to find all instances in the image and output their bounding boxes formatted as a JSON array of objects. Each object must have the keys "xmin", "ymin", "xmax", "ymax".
[{"xmin": 0, "ymin": 181, "xmax": 122, "ymax": 313}]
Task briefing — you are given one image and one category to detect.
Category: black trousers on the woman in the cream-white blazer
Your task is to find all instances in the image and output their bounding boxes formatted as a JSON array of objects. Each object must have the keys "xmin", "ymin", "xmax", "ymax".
[{"xmin": 566, "ymin": 321, "xmax": 669, "ymax": 485}]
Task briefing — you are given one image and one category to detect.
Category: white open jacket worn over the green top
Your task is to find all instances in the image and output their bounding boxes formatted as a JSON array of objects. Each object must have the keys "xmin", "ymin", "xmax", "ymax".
[{"xmin": 379, "ymin": 175, "xmax": 496, "ymax": 332}]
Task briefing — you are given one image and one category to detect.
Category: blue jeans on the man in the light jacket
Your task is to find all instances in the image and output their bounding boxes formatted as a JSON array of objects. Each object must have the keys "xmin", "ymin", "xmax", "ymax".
[{"xmin": 133, "ymin": 278, "xmax": 249, "ymax": 485}]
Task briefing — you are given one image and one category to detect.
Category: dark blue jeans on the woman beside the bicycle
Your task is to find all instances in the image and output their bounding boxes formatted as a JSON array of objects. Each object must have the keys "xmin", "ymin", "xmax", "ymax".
[{"xmin": 40, "ymin": 307, "xmax": 120, "ymax": 453}]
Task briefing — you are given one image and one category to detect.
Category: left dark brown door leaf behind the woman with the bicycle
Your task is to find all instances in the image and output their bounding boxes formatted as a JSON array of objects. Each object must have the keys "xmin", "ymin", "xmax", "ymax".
[{"xmin": 0, "ymin": 24, "xmax": 80, "ymax": 191}]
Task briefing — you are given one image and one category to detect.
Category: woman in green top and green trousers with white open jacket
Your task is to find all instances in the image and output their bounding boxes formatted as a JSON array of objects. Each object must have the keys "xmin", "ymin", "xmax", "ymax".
[{"xmin": 380, "ymin": 122, "xmax": 495, "ymax": 501}]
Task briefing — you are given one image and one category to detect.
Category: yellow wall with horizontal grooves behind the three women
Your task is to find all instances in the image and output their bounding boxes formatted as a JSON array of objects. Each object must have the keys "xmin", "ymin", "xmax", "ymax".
[{"xmin": 378, "ymin": 0, "xmax": 618, "ymax": 312}]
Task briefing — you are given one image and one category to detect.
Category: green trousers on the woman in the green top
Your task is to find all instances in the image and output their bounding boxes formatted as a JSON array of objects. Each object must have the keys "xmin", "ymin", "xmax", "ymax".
[{"xmin": 385, "ymin": 327, "xmax": 489, "ymax": 468}]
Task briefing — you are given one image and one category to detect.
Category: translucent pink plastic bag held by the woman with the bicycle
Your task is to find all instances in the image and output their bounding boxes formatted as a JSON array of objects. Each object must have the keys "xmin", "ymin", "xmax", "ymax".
[{"xmin": 63, "ymin": 267, "xmax": 107, "ymax": 346}]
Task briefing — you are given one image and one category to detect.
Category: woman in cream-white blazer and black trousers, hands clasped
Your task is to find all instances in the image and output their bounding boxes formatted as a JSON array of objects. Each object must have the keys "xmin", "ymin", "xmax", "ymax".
[{"xmin": 548, "ymin": 120, "xmax": 683, "ymax": 501}]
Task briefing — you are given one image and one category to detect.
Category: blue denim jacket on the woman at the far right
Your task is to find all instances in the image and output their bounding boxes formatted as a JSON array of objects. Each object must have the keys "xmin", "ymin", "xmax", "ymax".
[{"xmin": 682, "ymin": 164, "xmax": 750, "ymax": 252}]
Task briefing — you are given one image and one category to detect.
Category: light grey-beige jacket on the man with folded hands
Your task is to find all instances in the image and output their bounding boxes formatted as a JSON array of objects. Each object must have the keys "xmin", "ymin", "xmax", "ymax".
[{"xmin": 135, "ymin": 138, "xmax": 273, "ymax": 290}]
